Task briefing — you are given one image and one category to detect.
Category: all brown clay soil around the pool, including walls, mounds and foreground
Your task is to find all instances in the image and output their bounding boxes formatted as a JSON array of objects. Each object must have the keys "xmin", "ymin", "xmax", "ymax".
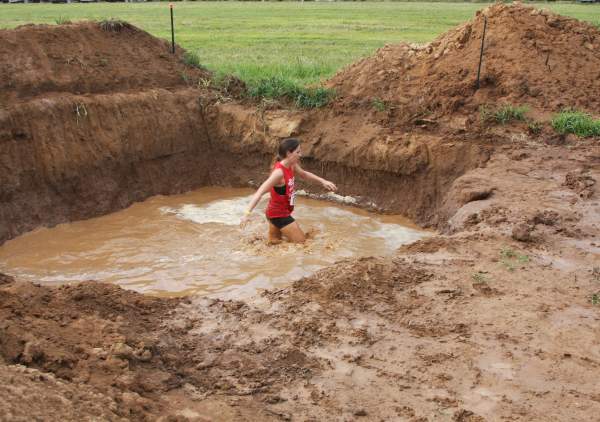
[{"xmin": 0, "ymin": 6, "xmax": 600, "ymax": 422}]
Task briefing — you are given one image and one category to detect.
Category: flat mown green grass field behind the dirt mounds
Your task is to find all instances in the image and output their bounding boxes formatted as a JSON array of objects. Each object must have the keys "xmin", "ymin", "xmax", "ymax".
[{"xmin": 0, "ymin": 2, "xmax": 600, "ymax": 84}]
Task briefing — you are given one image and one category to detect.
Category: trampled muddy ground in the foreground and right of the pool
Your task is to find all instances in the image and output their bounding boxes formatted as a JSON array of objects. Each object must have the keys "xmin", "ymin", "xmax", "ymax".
[{"xmin": 0, "ymin": 139, "xmax": 600, "ymax": 421}]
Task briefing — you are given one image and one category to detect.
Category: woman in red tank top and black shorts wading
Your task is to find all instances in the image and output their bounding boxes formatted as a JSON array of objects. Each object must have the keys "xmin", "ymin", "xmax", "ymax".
[{"xmin": 240, "ymin": 138, "xmax": 337, "ymax": 243}]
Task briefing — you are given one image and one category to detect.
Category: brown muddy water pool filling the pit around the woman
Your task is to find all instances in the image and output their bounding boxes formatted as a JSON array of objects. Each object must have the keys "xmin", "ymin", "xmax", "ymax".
[{"xmin": 0, "ymin": 188, "xmax": 427, "ymax": 298}]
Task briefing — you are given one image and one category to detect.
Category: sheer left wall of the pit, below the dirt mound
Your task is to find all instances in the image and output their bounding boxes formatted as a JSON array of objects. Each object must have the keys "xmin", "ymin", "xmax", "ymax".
[{"xmin": 0, "ymin": 90, "xmax": 216, "ymax": 241}]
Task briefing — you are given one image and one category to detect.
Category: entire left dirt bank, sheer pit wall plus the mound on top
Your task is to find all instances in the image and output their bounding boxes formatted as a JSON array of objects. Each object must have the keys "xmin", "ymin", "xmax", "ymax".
[{"xmin": 0, "ymin": 21, "xmax": 210, "ymax": 243}]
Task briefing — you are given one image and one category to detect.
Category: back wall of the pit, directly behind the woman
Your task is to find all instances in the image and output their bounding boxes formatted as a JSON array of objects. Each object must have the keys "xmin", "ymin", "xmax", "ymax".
[{"xmin": 207, "ymin": 103, "xmax": 491, "ymax": 226}]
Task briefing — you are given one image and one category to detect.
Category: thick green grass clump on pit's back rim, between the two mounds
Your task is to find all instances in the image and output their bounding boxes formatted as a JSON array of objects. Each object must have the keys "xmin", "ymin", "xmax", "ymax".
[{"xmin": 248, "ymin": 76, "xmax": 335, "ymax": 108}]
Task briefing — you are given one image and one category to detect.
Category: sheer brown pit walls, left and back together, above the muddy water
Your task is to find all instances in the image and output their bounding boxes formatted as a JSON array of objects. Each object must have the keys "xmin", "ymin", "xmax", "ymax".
[{"xmin": 0, "ymin": 92, "xmax": 486, "ymax": 242}]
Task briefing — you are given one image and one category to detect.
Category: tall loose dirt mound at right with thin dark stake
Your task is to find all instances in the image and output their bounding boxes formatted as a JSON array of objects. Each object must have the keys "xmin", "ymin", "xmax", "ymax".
[{"xmin": 329, "ymin": 4, "xmax": 600, "ymax": 124}]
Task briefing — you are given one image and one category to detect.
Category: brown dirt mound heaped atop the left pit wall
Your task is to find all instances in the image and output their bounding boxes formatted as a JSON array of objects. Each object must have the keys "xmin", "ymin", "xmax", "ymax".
[{"xmin": 0, "ymin": 22, "xmax": 209, "ymax": 104}]
